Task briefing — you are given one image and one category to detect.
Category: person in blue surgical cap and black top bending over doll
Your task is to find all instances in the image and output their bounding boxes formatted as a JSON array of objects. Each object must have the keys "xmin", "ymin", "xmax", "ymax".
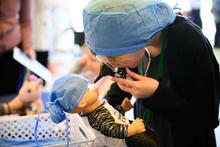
[{"xmin": 83, "ymin": 0, "xmax": 220, "ymax": 147}]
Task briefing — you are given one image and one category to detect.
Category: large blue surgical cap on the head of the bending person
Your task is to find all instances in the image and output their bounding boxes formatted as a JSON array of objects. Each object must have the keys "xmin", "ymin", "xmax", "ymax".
[{"xmin": 83, "ymin": 0, "xmax": 176, "ymax": 56}]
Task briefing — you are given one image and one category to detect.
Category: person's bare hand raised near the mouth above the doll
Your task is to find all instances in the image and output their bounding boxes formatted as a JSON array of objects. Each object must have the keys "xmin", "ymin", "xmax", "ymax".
[{"xmin": 112, "ymin": 68, "xmax": 159, "ymax": 98}]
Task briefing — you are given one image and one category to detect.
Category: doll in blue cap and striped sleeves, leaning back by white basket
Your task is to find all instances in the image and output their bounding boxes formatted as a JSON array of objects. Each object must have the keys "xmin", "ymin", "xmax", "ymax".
[{"xmin": 46, "ymin": 74, "xmax": 158, "ymax": 147}]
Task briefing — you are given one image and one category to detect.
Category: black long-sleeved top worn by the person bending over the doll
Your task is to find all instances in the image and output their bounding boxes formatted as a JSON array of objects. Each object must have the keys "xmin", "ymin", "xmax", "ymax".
[{"xmin": 105, "ymin": 16, "xmax": 220, "ymax": 147}]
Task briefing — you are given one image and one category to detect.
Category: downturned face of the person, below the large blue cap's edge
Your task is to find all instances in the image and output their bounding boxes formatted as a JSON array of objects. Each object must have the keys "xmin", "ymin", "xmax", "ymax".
[{"xmin": 93, "ymin": 48, "xmax": 145, "ymax": 68}]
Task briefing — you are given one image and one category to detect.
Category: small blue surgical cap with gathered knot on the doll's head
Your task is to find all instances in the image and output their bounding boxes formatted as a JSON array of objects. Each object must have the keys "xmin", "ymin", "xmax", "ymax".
[{"xmin": 46, "ymin": 74, "xmax": 88, "ymax": 123}]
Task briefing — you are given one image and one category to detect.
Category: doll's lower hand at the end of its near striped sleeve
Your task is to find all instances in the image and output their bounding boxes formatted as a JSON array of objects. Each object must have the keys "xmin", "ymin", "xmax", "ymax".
[{"xmin": 128, "ymin": 118, "xmax": 145, "ymax": 136}]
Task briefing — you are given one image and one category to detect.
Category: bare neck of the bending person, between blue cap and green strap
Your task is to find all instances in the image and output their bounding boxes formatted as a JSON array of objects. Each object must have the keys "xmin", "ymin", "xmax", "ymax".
[{"xmin": 147, "ymin": 32, "xmax": 162, "ymax": 57}]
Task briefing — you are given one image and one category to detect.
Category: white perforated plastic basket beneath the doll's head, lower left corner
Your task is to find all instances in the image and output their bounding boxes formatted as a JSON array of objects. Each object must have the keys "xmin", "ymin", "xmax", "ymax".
[{"xmin": 0, "ymin": 113, "xmax": 99, "ymax": 147}]
